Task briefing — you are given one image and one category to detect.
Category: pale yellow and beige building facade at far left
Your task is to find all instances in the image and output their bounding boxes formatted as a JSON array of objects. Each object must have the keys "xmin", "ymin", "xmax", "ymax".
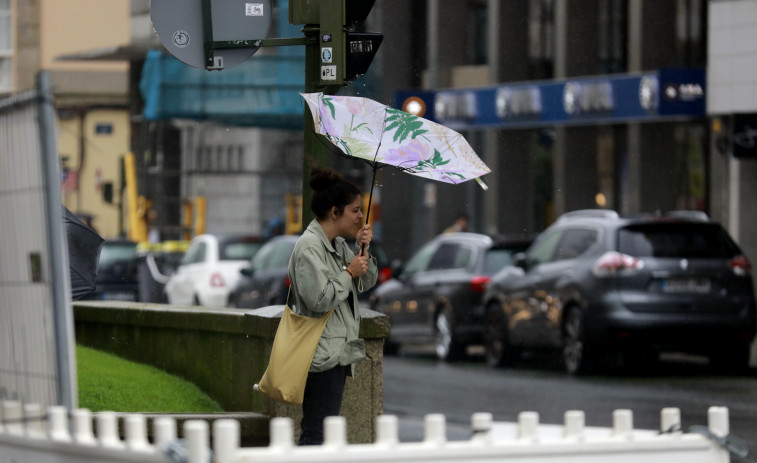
[{"xmin": 5, "ymin": 0, "xmax": 129, "ymax": 237}]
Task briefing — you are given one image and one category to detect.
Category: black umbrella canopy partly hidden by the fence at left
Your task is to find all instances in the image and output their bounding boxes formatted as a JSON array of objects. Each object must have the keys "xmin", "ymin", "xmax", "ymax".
[{"xmin": 63, "ymin": 206, "xmax": 105, "ymax": 300}]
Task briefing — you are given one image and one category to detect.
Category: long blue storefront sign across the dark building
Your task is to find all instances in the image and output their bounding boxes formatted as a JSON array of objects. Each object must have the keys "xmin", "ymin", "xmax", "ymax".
[{"xmin": 395, "ymin": 69, "xmax": 706, "ymax": 129}]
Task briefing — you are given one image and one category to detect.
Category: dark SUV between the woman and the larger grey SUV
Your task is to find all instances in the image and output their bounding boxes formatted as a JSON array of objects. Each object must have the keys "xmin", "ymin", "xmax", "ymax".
[{"xmin": 371, "ymin": 233, "xmax": 530, "ymax": 361}]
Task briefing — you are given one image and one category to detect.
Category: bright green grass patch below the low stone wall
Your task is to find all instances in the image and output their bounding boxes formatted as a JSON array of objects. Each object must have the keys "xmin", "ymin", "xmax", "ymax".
[{"xmin": 76, "ymin": 345, "xmax": 223, "ymax": 413}]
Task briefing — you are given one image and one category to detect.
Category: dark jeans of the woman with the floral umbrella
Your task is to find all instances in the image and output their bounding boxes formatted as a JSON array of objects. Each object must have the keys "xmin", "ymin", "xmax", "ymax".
[{"xmin": 299, "ymin": 365, "xmax": 350, "ymax": 445}]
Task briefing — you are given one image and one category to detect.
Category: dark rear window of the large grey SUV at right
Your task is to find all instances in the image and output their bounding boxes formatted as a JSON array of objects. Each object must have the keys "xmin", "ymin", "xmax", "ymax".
[{"xmin": 618, "ymin": 223, "xmax": 740, "ymax": 259}]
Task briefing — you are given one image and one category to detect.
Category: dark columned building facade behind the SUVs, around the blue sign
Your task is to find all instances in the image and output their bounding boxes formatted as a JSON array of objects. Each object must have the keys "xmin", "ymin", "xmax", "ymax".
[{"xmin": 369, "ymin": 0, "xmax": 757, "ymax": 270}]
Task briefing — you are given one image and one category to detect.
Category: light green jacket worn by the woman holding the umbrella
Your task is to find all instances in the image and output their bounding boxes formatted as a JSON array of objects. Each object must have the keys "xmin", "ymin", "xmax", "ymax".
[{"xmin": 289, "ymin": 220, "xmax": 378, "ymax": 373}]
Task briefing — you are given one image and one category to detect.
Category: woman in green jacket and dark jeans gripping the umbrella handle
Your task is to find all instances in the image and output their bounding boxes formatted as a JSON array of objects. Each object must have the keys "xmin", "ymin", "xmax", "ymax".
[{"xmin": 289, "ymin": 167, "xmax": 378, "ymax": 445}]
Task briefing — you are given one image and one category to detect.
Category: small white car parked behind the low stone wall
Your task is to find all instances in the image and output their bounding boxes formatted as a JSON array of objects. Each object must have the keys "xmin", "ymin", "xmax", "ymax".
[{"xmin": 166, "ymin": 234, "xmax": 263, "ymax": 307}]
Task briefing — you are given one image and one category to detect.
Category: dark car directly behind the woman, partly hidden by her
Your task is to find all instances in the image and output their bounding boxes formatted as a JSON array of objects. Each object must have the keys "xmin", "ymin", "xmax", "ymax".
[{"xmin": 229, "ymin": 235, "xmax": 391, "ymax": 309}]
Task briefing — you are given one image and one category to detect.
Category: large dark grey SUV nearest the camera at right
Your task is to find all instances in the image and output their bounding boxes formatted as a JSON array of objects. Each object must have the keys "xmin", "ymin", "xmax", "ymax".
[{"xmin": 484, "ymin": 210, "xmax": 757, "ymax": 374}]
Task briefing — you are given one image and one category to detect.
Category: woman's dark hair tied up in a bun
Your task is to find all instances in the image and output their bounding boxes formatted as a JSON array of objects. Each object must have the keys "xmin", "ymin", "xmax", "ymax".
[{"xmin": 310, "ymin": 166, "xmax": 360, "ymax": 220}]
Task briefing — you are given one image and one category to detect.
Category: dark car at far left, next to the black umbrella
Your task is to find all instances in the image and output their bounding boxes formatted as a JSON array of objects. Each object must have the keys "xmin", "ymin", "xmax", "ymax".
[{"xmin": 84, "ymin": 239, "xmax": 139, "ymax": 301}]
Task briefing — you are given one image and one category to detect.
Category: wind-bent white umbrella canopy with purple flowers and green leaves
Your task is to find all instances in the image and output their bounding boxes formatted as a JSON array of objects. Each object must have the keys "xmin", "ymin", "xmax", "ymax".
[{"xmin": 301, "ymin": 93, "xmax": 491, "ymax": 189}]
